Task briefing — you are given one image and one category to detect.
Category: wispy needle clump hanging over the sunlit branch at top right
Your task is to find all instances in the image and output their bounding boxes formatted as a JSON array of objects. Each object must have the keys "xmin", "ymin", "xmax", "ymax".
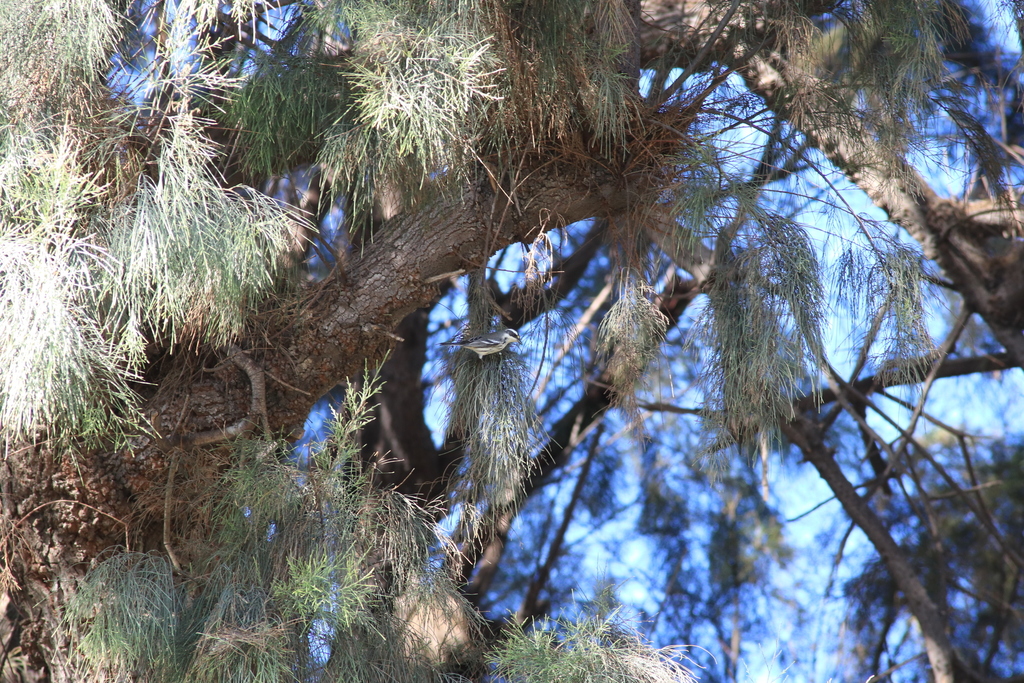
[{"xmin": 794, "ymin": 0, "xmax": 991, "ymax": 184}]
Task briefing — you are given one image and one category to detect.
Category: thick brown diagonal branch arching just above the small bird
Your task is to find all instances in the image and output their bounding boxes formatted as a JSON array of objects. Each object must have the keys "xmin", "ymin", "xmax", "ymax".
[{"xmin": 146, "ymin": 164, "xmax": 633, "ymax": 458}]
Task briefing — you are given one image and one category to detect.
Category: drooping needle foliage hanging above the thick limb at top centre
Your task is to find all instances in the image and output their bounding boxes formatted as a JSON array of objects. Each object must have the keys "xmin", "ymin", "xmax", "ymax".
[{"xmin": 227, "ymin": 0, "xmax": 638, "ymax": 225}]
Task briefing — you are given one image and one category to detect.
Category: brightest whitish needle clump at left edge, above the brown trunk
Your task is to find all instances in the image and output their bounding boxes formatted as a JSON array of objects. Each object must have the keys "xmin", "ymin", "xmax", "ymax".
[{"xmin": 0, "ymin": 225, "xmax": 133, "ymax": 438}]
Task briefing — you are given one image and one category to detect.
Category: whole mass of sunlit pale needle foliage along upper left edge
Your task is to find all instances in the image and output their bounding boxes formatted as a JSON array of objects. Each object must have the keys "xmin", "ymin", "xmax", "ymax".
[{"xmin": 0, "ymin": 0, "xmax": 303, "ymax": 439}]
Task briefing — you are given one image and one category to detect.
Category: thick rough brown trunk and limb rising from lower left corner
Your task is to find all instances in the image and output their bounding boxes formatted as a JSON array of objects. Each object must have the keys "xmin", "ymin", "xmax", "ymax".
[{"xmin": 2, "ymin": 164, "xmax": 631, "ymax": 681}]
